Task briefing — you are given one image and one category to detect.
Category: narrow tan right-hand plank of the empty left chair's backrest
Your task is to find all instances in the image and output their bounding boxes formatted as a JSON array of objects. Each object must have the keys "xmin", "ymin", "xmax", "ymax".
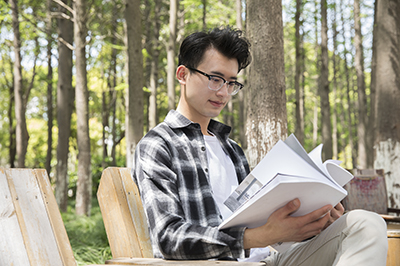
[{"xmin": 34, "ymin": 169, "xmax": 76, "ymax": 266}]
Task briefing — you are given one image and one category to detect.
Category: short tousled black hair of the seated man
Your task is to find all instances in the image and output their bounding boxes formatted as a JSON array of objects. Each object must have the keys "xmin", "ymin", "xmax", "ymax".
[{"xmin": 178, "ymin": 26, "xmax": 251, "ymax": 72}]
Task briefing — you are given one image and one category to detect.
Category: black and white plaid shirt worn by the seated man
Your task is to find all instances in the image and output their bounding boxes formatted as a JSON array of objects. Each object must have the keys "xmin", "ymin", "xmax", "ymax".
[{"xmin": 132, "ymin": 110, "xmax": 249, "ymax": 260}]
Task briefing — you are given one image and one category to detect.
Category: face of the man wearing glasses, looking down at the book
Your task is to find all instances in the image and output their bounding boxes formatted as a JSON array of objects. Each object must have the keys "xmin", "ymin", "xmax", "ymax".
[{"xmin": 180, "ymin": 48, "xmax": 238, "ymax": 122}]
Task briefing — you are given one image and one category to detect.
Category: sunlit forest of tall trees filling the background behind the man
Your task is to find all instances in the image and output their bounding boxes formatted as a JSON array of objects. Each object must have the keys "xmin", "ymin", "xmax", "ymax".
[{"xmin": 0, "ymin": 0, "xmax": 400, "ymax": 263}]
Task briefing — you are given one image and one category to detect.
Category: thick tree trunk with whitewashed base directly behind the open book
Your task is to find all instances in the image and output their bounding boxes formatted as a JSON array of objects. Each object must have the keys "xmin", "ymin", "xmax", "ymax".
[{"xmin": 247, "ymin": 0, "xmax": 287, "ymax": 168}]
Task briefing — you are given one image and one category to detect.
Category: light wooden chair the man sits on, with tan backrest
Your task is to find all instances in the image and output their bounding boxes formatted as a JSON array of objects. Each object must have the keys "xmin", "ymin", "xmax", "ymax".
[{"xmin": 97, "ymin": 167, "xmax": 265, "ymax": 266}]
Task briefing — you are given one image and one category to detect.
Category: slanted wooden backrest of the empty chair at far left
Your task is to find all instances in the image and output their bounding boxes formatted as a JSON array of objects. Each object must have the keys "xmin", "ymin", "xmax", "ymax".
[{"xmin": 0, "ymin": 168, "xmax": 76, "ymax": 266}]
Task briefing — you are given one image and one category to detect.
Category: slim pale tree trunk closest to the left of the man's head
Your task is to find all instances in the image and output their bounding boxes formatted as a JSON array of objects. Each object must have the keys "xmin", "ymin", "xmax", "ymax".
[{"xmin": 167, "ymin": 0, "xmax": 179, "ymax": 109}]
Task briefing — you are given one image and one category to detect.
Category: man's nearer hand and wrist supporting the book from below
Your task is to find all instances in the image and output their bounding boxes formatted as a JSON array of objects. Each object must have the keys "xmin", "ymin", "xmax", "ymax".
[{"xmin": 243, "ymin": 199, "xmax": 332, "ymax": 249}]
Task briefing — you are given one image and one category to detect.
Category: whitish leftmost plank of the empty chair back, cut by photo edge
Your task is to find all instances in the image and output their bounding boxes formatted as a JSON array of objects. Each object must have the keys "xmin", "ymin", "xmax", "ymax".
[{"xmin": 0, "ymin": 168, "xmax": 29, "ymax": 265}]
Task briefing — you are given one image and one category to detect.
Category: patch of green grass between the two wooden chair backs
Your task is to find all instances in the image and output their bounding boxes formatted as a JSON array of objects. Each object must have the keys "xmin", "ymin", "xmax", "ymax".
[{"xmin": 62, "ymin": 200, "xmax": 112, "ymax": 265}]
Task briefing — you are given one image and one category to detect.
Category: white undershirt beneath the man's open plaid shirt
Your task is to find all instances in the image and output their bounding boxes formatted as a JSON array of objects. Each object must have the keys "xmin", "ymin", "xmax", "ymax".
[{"xmin": 204, "ymin": 135, "xmax": 270, "ymax": 262}]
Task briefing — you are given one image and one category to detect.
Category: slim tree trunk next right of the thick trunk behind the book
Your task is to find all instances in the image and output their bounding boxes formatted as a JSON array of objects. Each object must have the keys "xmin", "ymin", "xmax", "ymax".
[{"xmin": 294, "ymin": 0, "xmax": 304, "ymax": 144}]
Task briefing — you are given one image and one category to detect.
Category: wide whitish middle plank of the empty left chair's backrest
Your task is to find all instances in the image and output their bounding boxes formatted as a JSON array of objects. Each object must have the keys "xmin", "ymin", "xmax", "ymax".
[{"xmin": 5, "ymin": 169, "xmax": 63, "ymax": 266}]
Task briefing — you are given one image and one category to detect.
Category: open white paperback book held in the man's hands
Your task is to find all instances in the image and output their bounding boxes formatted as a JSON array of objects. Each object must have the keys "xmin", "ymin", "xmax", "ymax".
[{"xmin": 219, "ymin": 134, "xmax": 353, "ymax": 251}]
